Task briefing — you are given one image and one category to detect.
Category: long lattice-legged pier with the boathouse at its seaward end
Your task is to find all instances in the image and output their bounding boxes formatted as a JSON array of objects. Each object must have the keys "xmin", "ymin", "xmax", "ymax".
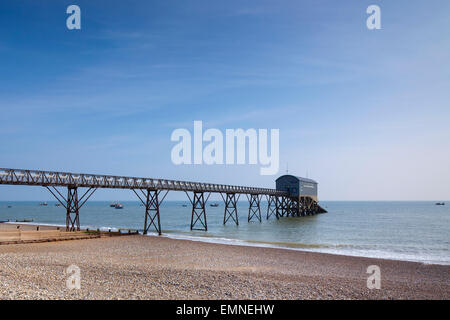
[{"xmin": 0, "ymin": 169, "xmax": 326, "ymax": 235}]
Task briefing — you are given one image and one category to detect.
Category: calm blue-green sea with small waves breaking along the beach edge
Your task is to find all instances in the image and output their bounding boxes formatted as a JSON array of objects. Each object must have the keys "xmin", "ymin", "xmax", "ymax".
[{"xmin": 0, "ymin": 201, "xmax": 450, "ymax": 265}]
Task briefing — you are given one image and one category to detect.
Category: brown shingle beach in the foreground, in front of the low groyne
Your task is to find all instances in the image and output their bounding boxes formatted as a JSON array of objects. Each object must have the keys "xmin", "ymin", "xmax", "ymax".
[{"xmin": 0, "ymin": 225, "xmax": 450, "ymax": 299}]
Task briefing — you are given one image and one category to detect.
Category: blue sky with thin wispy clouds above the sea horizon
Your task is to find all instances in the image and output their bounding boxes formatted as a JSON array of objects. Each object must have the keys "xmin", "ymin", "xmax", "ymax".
[{"xmin": 0, "ymin": 0, "xmax": 450, "ymax": 200}]
